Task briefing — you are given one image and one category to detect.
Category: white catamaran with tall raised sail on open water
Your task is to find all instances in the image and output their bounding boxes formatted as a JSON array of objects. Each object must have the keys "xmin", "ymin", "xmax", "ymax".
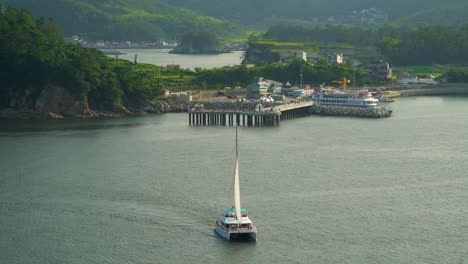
[{"xmin": 215, "ymin": 127, "xmax": 257, "ymax": 241}]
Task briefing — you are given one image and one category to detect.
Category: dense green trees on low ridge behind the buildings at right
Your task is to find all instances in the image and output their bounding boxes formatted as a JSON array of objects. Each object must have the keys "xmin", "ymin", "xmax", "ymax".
[{"xmin": 262, "ymin": 23, "xmax": 468, "ymax": 65}]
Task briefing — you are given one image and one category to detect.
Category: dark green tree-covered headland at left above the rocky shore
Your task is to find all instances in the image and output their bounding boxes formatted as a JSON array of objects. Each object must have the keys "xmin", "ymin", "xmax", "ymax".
[{"xmin": 0, "ymin": 8, "xmax": 194, "ymax": 107}]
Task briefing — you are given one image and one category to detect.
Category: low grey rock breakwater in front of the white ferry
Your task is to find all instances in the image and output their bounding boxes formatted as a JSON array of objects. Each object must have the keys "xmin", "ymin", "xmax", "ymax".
[{"xmin": 309, "ymin": 105, "xmax": 392, "ymax": 118}]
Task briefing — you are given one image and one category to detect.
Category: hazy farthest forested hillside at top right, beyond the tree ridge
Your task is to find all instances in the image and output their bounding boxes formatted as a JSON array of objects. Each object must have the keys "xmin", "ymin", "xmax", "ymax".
[{"xmin": 164, "ymin": 0, "xmax": 468, "ymax": 26}]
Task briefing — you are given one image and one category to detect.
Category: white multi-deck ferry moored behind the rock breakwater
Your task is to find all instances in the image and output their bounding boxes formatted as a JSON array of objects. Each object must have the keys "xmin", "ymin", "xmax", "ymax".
[{"xmin": 308, "ymin": 89, "xmax": 379, "ymax": 108}]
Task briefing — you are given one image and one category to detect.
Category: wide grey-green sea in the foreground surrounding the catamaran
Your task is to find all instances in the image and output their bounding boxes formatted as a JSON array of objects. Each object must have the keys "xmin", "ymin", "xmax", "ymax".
[{"xmin": 0, "ymin": 97, "xmax": 468, "ymax": 264}]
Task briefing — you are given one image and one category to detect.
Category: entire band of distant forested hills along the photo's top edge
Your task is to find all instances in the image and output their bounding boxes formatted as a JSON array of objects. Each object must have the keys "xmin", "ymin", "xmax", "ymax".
[{"xmin": 5, "ymin": 0, "xmax": 468, "ymax": 41}]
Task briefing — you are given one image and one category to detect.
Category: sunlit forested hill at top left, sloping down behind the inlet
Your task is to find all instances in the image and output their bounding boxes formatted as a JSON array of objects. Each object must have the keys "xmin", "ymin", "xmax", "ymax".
[{"xmin": 3, "ymin": 0, "xmax": 239, "ymax": 41}]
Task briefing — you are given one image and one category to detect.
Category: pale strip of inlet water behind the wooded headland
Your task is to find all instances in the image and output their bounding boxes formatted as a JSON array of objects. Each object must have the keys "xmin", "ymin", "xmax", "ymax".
[{"xmin": 103, "ymin": 49, "xmax": 244, "ymax": 70}]
